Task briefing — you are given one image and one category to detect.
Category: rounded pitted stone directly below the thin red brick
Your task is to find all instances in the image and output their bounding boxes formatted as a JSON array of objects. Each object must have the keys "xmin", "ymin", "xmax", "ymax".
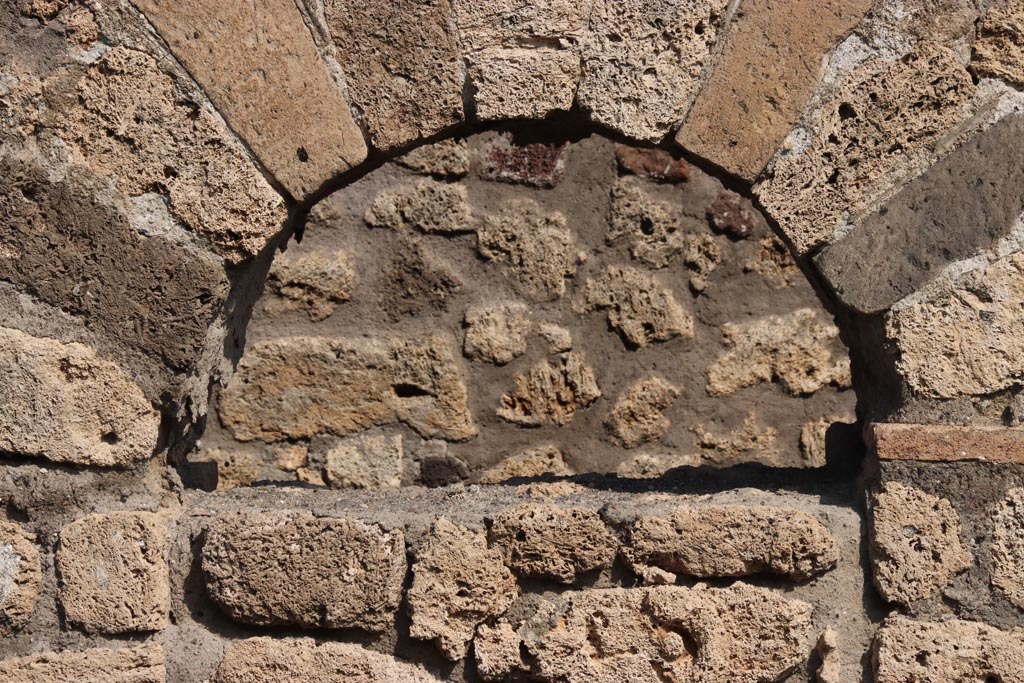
[{"xmin": 869, "ymin": 481, "xmax": 973, "ymax": 605}]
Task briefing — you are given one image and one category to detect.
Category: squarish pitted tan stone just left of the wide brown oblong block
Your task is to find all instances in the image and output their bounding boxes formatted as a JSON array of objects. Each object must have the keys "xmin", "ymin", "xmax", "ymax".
[{"xmin": 57, "ymin": 512, "xmax": 171, "ymax": 633}]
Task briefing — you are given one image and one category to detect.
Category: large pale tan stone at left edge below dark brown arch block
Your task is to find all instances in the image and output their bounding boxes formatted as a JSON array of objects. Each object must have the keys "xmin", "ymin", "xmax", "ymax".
[{"xmin": 0, "ymin": 328, "xmax": 160, "ymax": 467}]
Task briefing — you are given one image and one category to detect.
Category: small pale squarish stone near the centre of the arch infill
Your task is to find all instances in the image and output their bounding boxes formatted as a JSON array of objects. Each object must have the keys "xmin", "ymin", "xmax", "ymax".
[{"xmin": 463, "ymin": 301, "xmax": 531, "ymax": 366}]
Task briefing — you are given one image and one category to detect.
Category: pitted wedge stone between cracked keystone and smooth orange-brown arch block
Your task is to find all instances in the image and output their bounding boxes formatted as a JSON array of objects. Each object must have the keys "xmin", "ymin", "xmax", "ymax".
[{"xmin": 579, "ymin": 0, "xmax": 728, "ymax": 142}]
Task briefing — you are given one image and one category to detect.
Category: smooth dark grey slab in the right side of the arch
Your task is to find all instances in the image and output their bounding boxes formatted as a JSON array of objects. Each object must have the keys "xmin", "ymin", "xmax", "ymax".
[{"xmin": 815, "ymin": 113, "xmax": 1024, "ymax": 313}]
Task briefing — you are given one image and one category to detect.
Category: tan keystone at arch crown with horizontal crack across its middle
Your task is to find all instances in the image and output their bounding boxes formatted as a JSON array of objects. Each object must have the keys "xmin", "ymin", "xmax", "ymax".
[{"xmin": 454, "ymin": 0, "xmax": 591, "ymax": 121}]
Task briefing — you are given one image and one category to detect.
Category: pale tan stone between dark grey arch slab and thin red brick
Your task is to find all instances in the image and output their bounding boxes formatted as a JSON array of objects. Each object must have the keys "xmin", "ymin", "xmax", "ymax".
[{"xmin": 886, "ymin": 253, "xmax": 1024, "ymax": 398}]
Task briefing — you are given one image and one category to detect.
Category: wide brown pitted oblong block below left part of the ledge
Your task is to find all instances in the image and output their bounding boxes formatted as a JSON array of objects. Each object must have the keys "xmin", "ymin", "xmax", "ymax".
[{"xmin": 203, "ymin": 512, "xmax": 407, "ymax": 632}]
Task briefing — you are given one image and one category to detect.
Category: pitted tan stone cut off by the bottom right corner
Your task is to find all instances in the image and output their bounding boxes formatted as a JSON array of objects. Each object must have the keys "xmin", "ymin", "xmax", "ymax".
[{"xmin": 872, "ymin": 616, "xmax": 1024, "ymax": 683}]
